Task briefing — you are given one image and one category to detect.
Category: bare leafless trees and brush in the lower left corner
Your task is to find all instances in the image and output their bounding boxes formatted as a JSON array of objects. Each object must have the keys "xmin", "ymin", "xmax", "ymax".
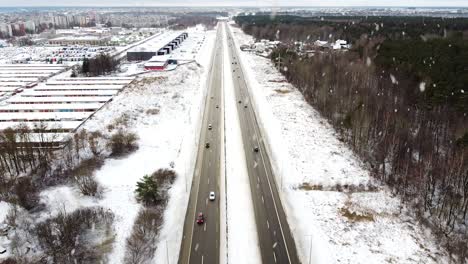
[{"xmin": 0, "ymin": 119, "xmax": 138, "ymax": 263}]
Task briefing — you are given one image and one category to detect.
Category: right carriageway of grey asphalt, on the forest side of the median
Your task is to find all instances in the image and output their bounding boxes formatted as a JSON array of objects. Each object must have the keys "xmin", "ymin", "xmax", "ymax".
[{"xmin": 224, "ymin": 23, "xmax": 300, "ymax": 264}]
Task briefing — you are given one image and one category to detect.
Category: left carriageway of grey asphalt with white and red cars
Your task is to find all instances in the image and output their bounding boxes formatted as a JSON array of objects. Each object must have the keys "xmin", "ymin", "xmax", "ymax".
[{"xmin": 178, "ymin": 26, "xmax": 224, "ymax": 264}]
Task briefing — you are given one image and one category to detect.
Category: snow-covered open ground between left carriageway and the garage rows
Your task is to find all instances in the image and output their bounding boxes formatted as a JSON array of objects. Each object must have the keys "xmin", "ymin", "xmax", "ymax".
[{"xmin": 0, "ymin": 24, "xmax": 216, "ymax": 263}]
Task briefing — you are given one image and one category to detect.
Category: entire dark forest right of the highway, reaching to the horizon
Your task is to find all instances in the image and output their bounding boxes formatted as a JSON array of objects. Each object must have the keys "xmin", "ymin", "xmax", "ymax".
[{"xmin": 236, "ymin": 16, "xmax": 468, "ymax": 259}]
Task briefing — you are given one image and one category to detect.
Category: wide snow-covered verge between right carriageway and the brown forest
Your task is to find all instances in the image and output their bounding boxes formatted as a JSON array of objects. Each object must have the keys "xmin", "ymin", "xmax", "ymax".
[{"xmin": 231, "ymin": 23, "xmax": 448, "ymax": 264}]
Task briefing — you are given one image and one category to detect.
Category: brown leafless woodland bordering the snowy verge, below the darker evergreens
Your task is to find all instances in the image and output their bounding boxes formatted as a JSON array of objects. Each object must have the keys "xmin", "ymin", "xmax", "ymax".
[{"xmin": 271, "ymin": 40, "xmax": 468, "ymax": 257}]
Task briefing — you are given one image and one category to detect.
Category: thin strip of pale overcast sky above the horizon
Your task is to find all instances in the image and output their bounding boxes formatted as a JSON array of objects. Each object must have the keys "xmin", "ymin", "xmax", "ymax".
[{"xmin": 0, "ymin": 0, "xmax": 468, "ymax": 7}]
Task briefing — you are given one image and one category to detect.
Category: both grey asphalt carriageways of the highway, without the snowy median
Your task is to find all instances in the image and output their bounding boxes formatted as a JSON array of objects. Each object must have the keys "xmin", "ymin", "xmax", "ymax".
[{"xmin": 178, "ymin": 22, "xmax": 300, "ymax": 264}]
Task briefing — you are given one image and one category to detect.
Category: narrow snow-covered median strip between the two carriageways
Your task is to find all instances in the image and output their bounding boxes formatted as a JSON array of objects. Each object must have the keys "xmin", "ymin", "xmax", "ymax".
[{"xmin": 223, "ymin": 22, "xmax": 261, "ymax": 264}]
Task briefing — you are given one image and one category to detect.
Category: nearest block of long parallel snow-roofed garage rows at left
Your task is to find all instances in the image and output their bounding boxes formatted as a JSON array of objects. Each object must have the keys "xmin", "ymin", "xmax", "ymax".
[{"xmin": 0, "ymin": 72, "xmax": 134, "ymax": 147}]
